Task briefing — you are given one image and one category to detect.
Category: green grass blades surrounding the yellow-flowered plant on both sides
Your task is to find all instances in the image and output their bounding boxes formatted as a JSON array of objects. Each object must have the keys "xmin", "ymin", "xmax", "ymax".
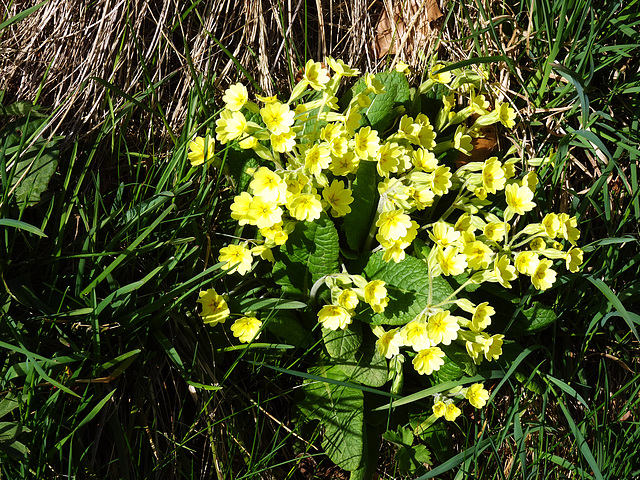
[{"xmin": 0, "ymin": 0, "xmax": 640, "ymax": 479}]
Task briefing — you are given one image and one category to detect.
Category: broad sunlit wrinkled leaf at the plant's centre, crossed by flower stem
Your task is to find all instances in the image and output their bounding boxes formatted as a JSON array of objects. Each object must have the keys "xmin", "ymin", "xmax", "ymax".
[{"xmin": 363, "ymin": 252, "xmax": 455, "ymax": 325}]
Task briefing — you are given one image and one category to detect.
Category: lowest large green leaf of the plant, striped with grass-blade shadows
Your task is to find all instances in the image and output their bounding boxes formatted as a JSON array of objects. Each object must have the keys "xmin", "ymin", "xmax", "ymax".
[{"xmin": 298, "ymin": 364, "xmax": 364, "ymax": 471}]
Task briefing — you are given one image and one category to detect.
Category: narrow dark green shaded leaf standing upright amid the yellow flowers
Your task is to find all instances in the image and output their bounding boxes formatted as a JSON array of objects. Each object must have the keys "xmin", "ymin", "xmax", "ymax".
[{"xmin": 344, "ymin": 162, "xmax": 378, "ymax": 251}]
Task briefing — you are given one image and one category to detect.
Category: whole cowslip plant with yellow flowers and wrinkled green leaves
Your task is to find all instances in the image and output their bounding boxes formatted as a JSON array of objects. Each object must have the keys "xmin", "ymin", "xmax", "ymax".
[{"xmin": 189, "ymin": 58, "xmax": 582, "ymax": 478}]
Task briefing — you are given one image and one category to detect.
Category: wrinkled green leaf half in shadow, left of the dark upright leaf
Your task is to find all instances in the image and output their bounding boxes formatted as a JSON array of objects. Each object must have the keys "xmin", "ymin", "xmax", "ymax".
[{"xmin": 273, "ymin": 213, "xmax": 340, "ymax": 296}]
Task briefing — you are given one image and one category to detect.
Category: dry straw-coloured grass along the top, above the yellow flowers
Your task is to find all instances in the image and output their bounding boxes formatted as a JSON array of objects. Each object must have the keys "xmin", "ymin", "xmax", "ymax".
[{"xmin": 0, "ymin": 0, "xmax": 476, "ymax": 141}]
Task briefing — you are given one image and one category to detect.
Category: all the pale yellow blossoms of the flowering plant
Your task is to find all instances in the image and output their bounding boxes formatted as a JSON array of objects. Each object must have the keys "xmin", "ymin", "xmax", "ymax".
[{"xmin": 194, "ymin": 58, "xmax": 583, "ymax": 420}]
